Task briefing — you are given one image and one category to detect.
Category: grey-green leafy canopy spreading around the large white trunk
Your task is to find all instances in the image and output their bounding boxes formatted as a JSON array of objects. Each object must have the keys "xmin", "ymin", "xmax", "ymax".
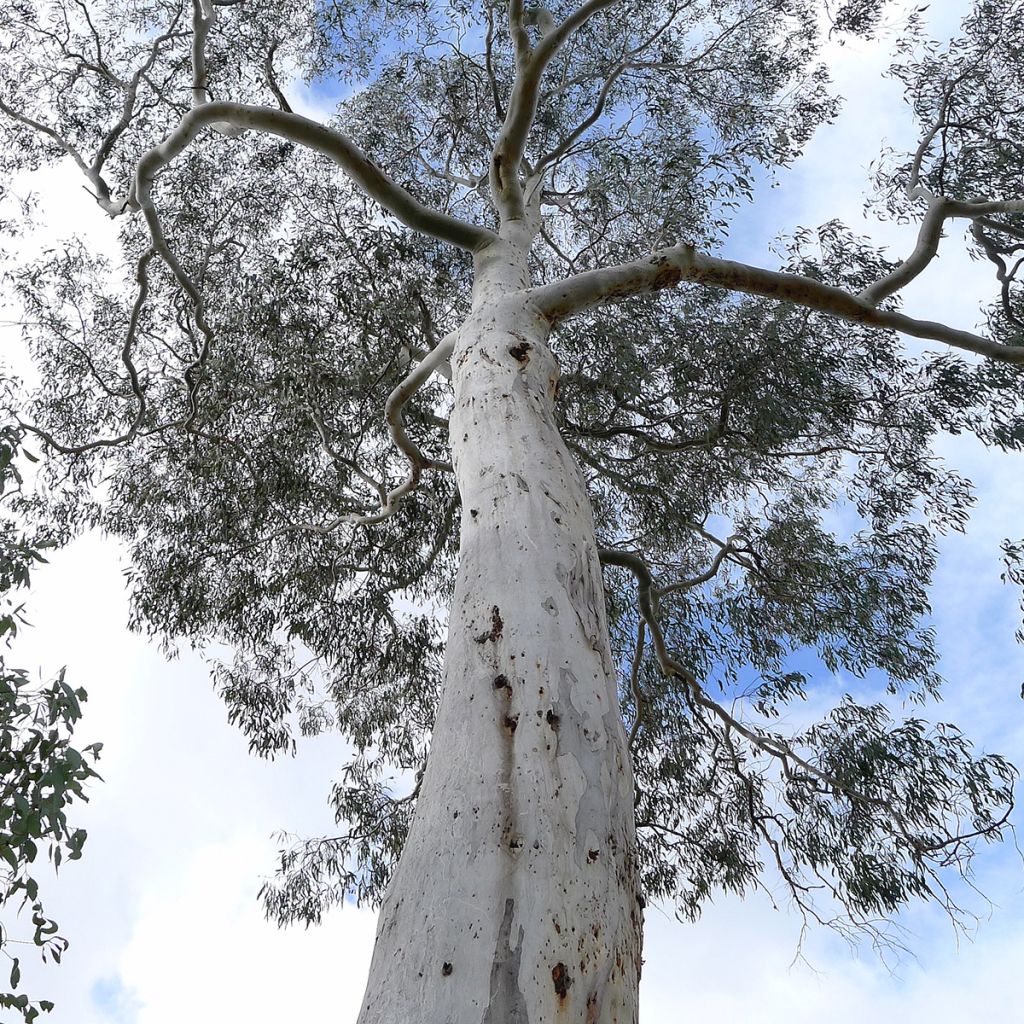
[{"xmin": 0, "ymin": 0, "xmax": 1024, "ymax": 950}]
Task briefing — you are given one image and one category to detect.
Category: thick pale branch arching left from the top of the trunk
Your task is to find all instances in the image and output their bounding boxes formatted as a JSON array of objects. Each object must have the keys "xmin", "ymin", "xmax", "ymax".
[{"xmin": 129, "ymin": 101, "xmax": 495, "ymax": 251}]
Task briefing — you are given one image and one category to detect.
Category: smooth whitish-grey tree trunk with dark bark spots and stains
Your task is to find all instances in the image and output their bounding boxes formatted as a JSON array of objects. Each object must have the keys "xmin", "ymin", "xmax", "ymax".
[{"xmin": 359, "ymin": 245, "xmax": 641, "ymax": 1024}]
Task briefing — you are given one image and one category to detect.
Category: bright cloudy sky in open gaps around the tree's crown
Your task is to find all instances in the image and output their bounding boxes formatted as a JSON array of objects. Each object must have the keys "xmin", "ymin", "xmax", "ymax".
[{"xmin": 2, "ymin": 0, "xmax": 1024, "ymax": 1024}]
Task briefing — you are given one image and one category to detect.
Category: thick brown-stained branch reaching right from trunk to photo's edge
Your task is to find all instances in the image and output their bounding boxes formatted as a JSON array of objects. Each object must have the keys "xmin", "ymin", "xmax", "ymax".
[{"xmin": 530, "ymin": 242, "xmax": 1024, "ymax": 365}]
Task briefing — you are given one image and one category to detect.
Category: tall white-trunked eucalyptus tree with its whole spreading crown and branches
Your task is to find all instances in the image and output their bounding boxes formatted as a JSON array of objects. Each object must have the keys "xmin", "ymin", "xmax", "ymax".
[{"xmin": 0, "ymin": 0, "xmax": 1024, "ymax": 1024}]
